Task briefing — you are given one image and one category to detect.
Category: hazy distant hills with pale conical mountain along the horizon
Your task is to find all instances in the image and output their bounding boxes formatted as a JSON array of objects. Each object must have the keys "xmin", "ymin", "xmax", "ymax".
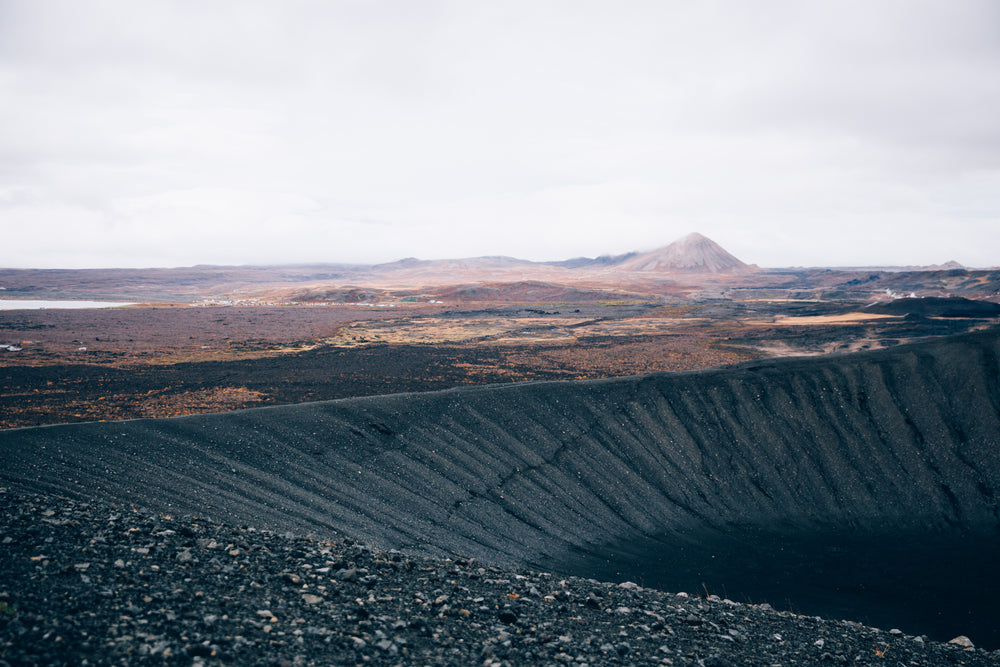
[{"xmin": 0, "ymin": 233, "xmax": 1000, "ymax": 303}]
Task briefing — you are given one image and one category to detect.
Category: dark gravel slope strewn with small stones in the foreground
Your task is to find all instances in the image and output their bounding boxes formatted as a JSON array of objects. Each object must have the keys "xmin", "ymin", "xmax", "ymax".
[{"xmin": 0, "ymin": 489, "xmax": 1000, "ymax": 667}]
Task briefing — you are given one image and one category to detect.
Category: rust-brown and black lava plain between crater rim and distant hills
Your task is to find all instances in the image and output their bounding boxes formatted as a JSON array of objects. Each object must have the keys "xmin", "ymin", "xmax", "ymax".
[{"xmin": 0, "ymin": 297, "xmax": 1000, "ymax": 429}]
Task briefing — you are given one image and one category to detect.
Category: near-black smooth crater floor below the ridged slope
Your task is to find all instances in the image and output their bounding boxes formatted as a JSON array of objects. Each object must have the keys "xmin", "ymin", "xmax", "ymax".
[{"xmin": 559, "ymin": 526, "xmax": 1000, "ymax": 647}]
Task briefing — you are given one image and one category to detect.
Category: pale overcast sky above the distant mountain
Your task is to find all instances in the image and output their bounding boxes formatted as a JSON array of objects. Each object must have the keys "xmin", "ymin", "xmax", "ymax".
[{"xmin": 0, "ymin": 0, "xmax": 1000, "ymax": 267}]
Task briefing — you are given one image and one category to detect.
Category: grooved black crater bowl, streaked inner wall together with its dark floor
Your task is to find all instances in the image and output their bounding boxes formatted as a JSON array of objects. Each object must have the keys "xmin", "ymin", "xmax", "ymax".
[{"xmin": 0, "ymin": 331, "xmax": 1000, "ymax": 647}]
